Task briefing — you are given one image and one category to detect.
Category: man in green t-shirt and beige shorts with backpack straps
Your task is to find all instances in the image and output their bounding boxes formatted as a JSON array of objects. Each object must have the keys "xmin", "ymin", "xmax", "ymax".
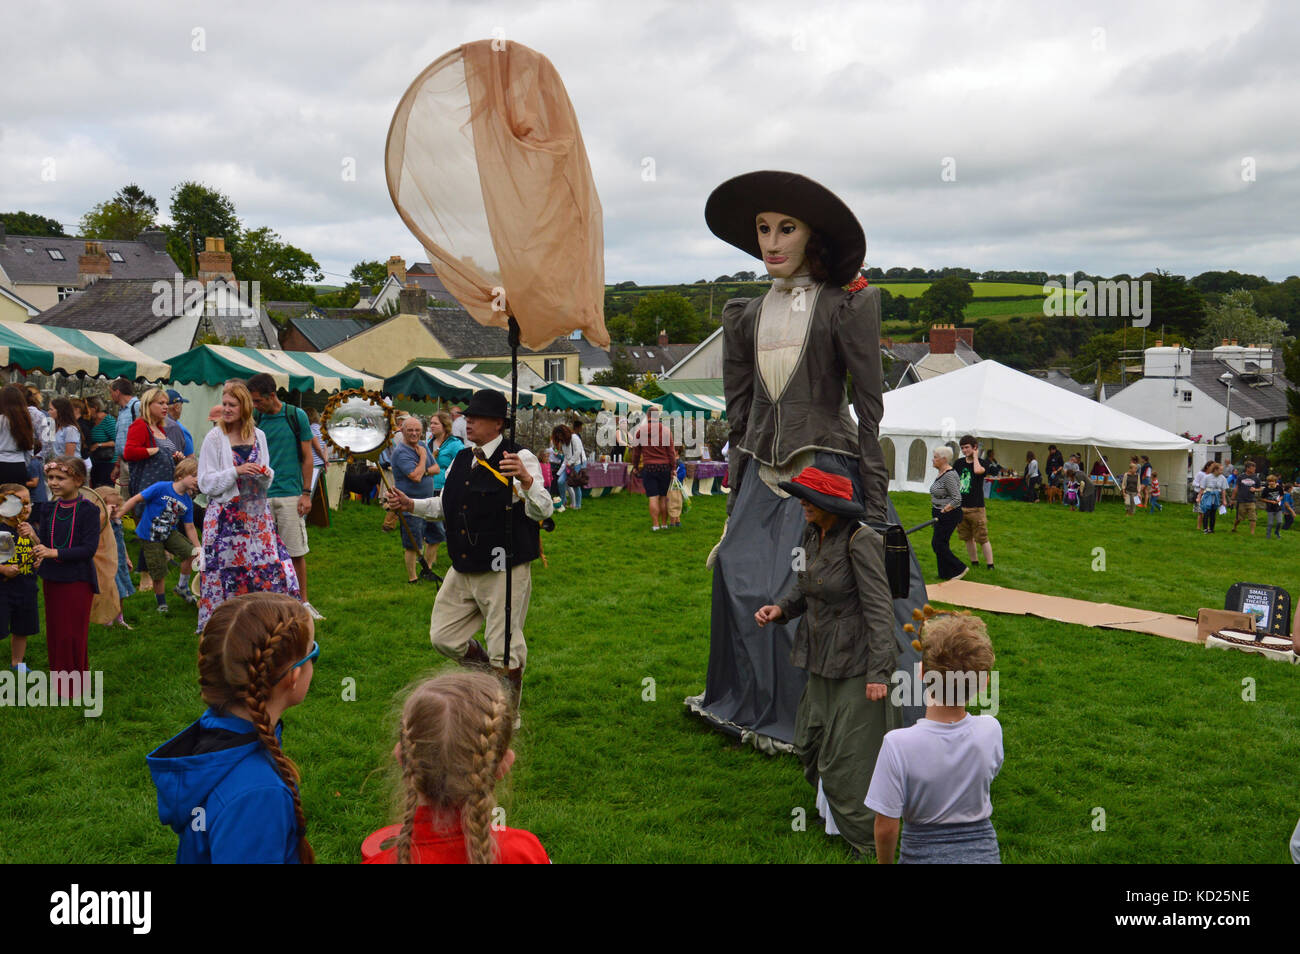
[{"xmin": 248, "ymin": 374, "xmax": 325, "ymax": 620}]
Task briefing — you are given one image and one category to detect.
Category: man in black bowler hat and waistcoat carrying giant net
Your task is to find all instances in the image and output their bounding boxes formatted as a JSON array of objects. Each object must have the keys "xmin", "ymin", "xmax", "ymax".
[{"xmin": 385, "ymin": 391, "xmax": 553, "ymax": 712}]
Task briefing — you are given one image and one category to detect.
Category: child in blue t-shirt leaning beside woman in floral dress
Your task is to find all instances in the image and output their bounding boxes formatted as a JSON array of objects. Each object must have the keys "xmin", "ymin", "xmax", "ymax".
[{"xmin": 122, "ymin": 458, "xmax": 203, "ymax": 613}]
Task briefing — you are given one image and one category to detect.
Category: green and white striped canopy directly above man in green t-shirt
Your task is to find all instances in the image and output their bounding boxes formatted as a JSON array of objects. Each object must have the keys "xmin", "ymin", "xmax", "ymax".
[{"xmin": 172, "ymin": 344, "xmax": 384, "ymax": 391}]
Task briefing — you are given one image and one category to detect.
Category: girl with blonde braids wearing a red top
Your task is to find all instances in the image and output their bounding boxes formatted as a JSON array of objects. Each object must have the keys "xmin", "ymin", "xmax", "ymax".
[{"xmin": 361, "ymin": 669, "xmax": 550, "ymax": 864}]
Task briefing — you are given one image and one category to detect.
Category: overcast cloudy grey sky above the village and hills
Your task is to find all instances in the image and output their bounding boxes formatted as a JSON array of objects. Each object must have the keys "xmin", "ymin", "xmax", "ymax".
[{"xmin": 0, "ymin": 0, "xmax": 1300, "ymax": 283}]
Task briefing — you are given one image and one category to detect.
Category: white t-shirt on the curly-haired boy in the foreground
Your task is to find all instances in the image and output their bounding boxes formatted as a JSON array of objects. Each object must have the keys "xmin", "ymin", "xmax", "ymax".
[{"xmin": 866, "ymin": 715, "xmax": 1002, "ymax": 824}]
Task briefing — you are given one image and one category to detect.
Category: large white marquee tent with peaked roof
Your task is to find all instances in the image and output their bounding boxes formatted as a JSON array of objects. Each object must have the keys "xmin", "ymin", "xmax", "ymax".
[{"xmin": 880, "ymin": 361, "xmax": 1192, "ymax": 503}]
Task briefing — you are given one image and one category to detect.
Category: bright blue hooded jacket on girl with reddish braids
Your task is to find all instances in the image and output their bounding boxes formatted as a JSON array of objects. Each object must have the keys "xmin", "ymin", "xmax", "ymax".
[{"xmin": 147, "ymin": 708, "xmax": 298, "ymax": 864}]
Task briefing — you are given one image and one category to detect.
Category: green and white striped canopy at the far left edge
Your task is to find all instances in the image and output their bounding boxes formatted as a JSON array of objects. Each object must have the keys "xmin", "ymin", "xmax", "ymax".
[{"xmin": 0, "ymin": 321, "xmax": 172, "ymax": 381}]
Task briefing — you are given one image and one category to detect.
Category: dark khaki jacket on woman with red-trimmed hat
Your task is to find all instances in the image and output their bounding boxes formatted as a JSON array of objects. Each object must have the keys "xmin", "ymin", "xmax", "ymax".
[{"xmin": 779, "ymin": 517, "xmax": 898, "ymax": 685}]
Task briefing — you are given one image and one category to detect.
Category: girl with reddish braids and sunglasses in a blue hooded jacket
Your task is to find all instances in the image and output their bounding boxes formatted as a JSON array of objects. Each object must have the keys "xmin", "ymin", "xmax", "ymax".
[{"xmin": 148, "ymin": 593, "xmax": 320, "ymax": 864}]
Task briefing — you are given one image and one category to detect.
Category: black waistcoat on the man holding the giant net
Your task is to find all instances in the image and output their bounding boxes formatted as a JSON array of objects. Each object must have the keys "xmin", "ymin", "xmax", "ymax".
[{"xmin": 442, "ymin": 439, "xmax": 541, "ymax": 573}]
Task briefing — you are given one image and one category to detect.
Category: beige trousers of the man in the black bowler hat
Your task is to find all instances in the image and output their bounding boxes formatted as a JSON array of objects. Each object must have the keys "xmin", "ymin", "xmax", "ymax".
[{"xmin": 429, "ymin": 563, "xmax": 533, "ymax": 669}]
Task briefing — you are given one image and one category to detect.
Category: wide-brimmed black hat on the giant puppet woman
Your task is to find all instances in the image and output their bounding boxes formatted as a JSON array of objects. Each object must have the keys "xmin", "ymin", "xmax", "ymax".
[{"xmin": 705, "ymin": 170, "xmax": 867, "ymax": 285}]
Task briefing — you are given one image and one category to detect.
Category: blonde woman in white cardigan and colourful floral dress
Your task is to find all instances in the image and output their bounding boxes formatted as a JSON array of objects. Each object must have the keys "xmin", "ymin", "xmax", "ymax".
[{"xmin": 199, "ymin": 381, "xmax": 299, "ymax": 633}]
